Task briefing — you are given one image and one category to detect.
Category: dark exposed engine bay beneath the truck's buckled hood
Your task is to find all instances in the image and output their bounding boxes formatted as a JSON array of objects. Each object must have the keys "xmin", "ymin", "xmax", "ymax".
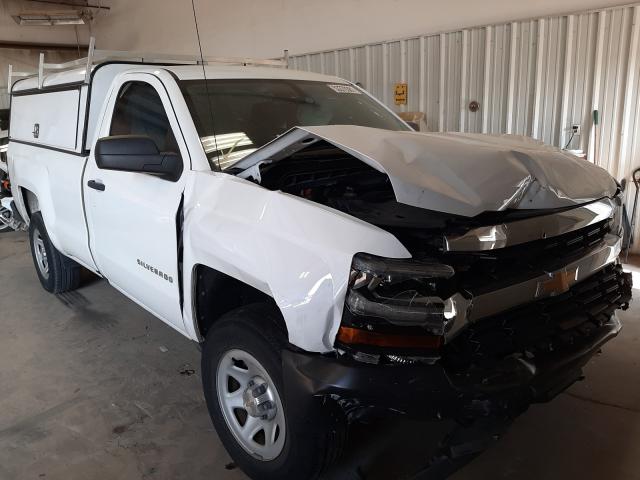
[{"xmin": 244, "ymin": 141, "xmax": 600, "ymax": 257}]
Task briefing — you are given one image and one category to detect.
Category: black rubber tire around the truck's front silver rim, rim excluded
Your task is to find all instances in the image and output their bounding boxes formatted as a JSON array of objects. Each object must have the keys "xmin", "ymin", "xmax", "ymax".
[{"xmin": 202, "ymin": 304, "xmax": 346, "ymax": 480}]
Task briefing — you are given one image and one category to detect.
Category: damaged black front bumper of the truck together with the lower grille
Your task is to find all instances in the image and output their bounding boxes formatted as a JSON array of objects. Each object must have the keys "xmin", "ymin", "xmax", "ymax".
[{"xmin": 283, "ymin": 264, "xmax": 631, "ymax": 420}]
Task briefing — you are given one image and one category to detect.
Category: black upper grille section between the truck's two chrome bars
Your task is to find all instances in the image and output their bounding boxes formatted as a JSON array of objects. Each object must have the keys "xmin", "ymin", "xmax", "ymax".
[{"xmin": 443, "ymin": 220, "xmax": 611, "ymax": 295}]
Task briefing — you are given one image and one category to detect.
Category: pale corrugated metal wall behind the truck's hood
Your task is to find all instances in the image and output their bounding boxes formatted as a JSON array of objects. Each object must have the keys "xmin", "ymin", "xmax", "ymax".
[{"xmin": 291, "ymin": 4, "xmax": 640, "ymax": 251}]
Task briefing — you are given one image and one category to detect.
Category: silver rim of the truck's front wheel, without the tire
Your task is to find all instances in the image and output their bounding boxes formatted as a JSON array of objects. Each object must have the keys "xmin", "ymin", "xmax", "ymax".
[{"xmin": 216, "ymin": 349, "xmax": 286, "ymax": 461}]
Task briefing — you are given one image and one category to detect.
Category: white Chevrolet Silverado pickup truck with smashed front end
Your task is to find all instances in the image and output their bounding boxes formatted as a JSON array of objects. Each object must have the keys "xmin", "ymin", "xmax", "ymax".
[{"xmin": 8, "ymin": 58, "xmax": 631, "ymax": 480}]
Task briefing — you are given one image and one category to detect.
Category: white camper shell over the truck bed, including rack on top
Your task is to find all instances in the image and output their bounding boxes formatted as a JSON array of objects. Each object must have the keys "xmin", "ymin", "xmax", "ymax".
[{"xmin": 8, "ymin": 43, "xmax": 288, "ymax": 154}]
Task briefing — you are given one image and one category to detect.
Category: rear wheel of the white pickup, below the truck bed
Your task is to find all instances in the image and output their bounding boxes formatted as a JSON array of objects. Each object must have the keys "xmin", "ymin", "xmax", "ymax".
[{"xmin": 29, "ymin": 212, "xmax": 82, "ymax": 293}]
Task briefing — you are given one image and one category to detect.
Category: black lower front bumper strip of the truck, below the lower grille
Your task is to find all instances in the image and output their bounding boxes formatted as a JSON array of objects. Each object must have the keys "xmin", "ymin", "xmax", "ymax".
[{"xmin": 283, "ymin": 315, "xmax": 622, "ymax": 419}]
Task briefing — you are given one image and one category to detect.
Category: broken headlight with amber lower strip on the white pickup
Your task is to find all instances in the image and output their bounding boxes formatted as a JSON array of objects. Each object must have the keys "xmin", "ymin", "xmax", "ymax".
[{"xmin": 337, "ymin": 253, "xmax": 460, "ymax": 358}]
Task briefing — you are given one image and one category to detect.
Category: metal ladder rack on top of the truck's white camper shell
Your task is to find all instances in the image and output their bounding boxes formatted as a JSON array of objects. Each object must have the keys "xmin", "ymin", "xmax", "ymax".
[{"xmin": 7, "ymin": 37, "xmax": 289, "ymax": 94}]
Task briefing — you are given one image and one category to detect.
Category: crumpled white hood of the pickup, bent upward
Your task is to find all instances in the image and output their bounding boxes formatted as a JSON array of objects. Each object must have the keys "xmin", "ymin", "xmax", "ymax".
[{"xmin": 235, "ymin": 125, "xmax": 617, "ymax": 217}]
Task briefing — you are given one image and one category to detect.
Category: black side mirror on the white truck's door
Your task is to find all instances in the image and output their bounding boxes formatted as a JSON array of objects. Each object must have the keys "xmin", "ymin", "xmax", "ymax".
[{"xmin": 95, "ymin": 135, "xmax": 182, "ymax": 182}]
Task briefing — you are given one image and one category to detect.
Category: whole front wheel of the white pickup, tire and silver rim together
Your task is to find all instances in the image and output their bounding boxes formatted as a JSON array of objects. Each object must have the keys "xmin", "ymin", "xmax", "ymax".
[{"xmin": 202, "ymin": 304, "xmax": 346, "ymax": 480}]
